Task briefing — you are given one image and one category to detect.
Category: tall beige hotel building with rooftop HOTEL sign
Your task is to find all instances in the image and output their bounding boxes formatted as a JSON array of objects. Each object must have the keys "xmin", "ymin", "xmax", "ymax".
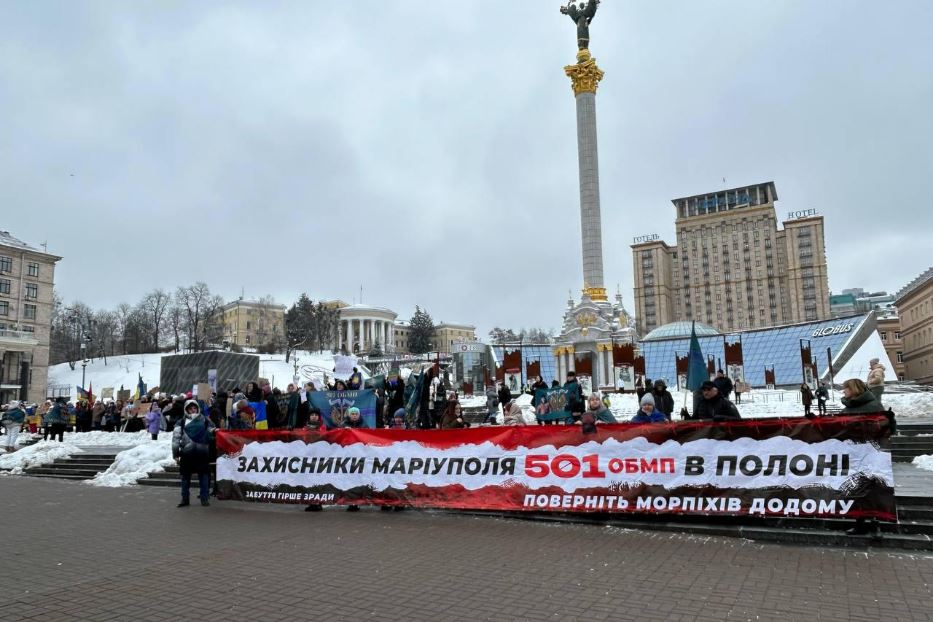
[{"xmin": 632, "ymin": 182, "xmax": 830, "ymax": 335}]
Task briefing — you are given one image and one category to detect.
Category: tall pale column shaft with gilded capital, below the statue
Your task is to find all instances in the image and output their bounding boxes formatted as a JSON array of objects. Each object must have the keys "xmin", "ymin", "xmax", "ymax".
[{"xmin": 564, "ymin": 49, "xmax": 608, "ymax": 300}]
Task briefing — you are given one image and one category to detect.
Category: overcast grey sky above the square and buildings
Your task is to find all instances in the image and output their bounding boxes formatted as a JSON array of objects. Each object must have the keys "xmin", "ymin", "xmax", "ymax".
[{"xmin": 0, "ymin": 0, "xmax": 933, "ymax": 337}]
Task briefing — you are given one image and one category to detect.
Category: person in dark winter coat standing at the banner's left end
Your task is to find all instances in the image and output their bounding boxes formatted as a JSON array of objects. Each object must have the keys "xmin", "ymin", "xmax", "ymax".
[{"xmin": 172, "ymin": 400, "xmax": 215, "ymax": 508}]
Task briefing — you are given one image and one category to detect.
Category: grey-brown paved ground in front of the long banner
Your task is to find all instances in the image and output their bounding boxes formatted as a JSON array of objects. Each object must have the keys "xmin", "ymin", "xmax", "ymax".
[{"xmin": 0, "ymin": 477, "xmax": 933, "ymax": 622}]
